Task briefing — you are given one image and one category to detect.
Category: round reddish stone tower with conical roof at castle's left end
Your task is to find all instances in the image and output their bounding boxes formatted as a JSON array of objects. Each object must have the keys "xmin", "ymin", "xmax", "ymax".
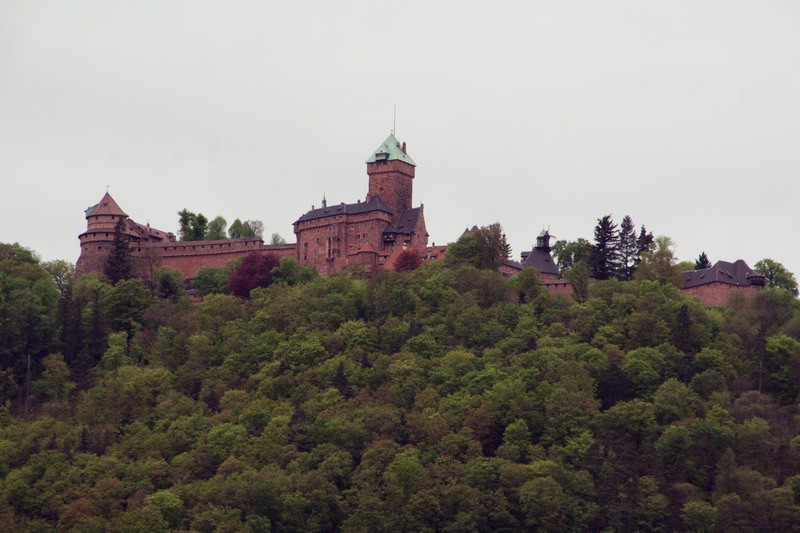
[{"xmin": 75, "ymin": 192, "xmax": 128, "ymax": 277}]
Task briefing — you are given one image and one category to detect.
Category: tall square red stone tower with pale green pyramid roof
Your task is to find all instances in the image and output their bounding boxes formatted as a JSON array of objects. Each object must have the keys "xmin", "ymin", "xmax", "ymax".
[{"xmin": 367, "ymin": 133, "xmax": 417, "ymax": 221}]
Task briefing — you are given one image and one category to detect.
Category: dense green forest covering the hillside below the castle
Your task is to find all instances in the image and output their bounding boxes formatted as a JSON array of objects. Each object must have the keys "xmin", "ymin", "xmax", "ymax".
[{"xmin": 0, "ymin": 237, "xmax": 800, "ymax": 533}]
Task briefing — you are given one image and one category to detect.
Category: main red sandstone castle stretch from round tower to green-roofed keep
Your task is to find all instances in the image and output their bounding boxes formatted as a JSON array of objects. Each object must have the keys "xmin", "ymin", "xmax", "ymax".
[{"xmin": 76, "ymin": 134, "xmax": 432, "ymax": 279}]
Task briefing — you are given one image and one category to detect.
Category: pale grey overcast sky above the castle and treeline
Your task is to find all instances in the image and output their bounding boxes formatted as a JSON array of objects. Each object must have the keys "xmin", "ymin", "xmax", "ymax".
[{"xmin": 0, "ymin": 0, "xmax": 800, "ymax": 273}]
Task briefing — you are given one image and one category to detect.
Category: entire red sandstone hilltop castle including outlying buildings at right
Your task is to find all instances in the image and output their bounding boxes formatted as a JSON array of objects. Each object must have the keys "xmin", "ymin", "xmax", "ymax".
[{"xmin": 76, "ymin": 134, "xmax": 766, "ymax": 306}]
